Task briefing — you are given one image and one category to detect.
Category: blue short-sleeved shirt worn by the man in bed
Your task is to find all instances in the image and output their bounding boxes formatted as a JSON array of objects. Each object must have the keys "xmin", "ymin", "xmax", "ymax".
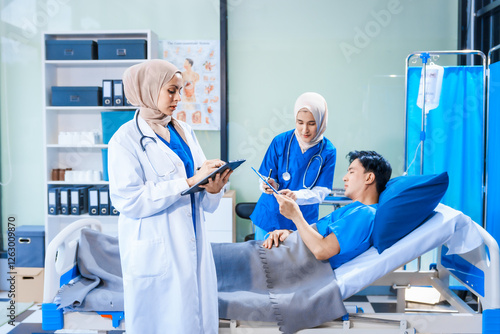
[{"xmin": 316, "ymin": 202, "xmax": 378, "ymax": 269}]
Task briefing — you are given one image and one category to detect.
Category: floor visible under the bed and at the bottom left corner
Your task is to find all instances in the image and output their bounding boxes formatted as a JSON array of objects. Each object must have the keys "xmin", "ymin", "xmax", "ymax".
[{"xmin": 0, "ymin": 292, "xmax": 477, "ymax": 334}]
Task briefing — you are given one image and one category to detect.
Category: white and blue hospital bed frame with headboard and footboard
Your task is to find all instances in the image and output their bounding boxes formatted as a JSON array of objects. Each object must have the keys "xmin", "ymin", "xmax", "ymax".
[{"xmin": 42, "ymin": 219, "xmax": 500, "ymax": 334}]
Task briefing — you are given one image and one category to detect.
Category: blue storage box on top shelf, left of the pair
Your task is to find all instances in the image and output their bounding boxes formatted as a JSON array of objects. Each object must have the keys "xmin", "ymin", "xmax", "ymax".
[{"xmin": 45, "ymin": 39, "xmax": 97, "ymax": 60}]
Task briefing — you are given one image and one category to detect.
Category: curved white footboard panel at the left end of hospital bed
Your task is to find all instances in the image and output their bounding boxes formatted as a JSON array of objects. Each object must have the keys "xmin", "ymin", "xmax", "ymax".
[{"xmin": 43, "ymin": 218, "xmax": 102, "ymax": 303}]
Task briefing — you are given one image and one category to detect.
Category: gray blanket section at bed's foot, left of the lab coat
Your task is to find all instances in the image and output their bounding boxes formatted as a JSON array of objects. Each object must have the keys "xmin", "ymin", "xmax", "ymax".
[{"xmin": 56, "ymin": 229, "xmax": 123, "ymax": 312}]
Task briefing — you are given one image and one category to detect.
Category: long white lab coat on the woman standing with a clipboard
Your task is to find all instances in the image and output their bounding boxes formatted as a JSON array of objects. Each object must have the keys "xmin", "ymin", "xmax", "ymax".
[{"xmin": 108, "ymin": 113, "xmax": 222, "ymax": 334}]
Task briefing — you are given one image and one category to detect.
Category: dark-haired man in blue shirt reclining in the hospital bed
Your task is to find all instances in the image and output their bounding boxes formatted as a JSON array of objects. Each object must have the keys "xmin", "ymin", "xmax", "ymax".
[{"xmin": 263, "ymin": 151, "xmax": 392, "ymax": 269}]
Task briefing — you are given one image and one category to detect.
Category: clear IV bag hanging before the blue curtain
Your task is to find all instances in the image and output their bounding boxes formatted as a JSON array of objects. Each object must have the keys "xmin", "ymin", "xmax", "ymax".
[{"xmin": 417, "ymin": 64, "xmax": 444, "ymax": 114}]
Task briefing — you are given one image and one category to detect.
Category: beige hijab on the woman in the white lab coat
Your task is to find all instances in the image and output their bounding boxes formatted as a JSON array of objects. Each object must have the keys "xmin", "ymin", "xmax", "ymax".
[{"xmin": 123, "ymin": 59, "xmax": 187, "ymax": 143}]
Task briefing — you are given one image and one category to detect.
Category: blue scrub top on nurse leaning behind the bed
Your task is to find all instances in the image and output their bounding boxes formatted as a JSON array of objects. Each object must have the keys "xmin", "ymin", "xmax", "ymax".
[{"xmin": 250, "ymin": 129, "xmax": 337, "ymax": 232}]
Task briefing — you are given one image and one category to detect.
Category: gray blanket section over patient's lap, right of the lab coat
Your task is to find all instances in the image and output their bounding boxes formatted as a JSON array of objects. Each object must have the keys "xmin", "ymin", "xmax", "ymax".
[{"xmin": 212, "ymin": 228, "xmax": 347, "ymax": 333}]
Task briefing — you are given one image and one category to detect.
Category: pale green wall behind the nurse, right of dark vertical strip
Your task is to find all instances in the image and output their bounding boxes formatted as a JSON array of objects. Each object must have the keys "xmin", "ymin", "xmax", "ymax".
[{"xmin": 228, "ymin": 0, "xmax": 458, "ymax": 234}]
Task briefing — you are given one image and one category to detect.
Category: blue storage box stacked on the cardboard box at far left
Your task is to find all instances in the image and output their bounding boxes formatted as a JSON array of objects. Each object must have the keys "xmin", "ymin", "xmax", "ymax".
[{"xmin": 16, "ymin": 225, "xmax": 45, "ymax": 268}]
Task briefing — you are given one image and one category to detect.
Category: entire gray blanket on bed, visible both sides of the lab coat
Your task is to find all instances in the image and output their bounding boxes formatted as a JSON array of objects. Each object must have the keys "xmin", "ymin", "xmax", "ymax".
[{"xmin": 55, "ymin": 229, "xmax": 347, "ymax": 333}]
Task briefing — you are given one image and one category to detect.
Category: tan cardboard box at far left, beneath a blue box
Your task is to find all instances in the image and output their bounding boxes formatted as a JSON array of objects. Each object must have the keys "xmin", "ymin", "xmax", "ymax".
[{"xmin": 13, "ymin": 267, "xmax": 44, "ymax": 303}]
